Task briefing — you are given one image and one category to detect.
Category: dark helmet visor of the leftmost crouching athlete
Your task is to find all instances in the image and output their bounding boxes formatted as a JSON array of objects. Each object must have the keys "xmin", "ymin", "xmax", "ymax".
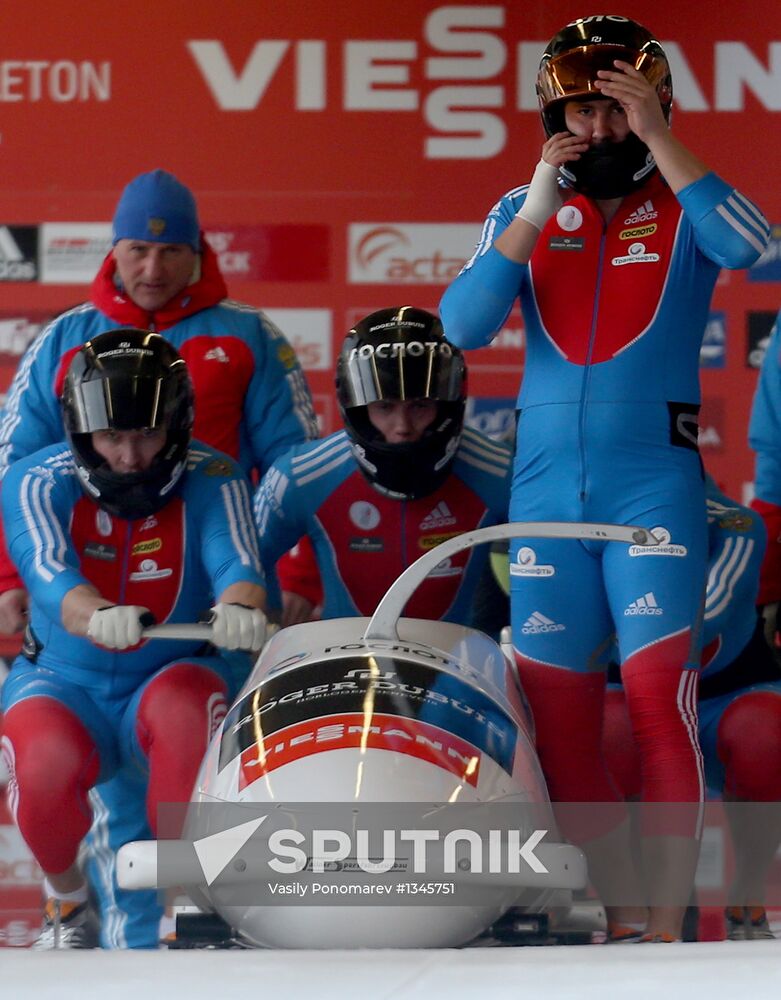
[{"xmin": 70, "ymin": 375, "xmax": 182, "ymax": 434}]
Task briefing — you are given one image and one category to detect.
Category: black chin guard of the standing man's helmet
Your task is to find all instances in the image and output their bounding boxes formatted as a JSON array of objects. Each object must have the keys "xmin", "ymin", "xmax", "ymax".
[{"xmin": 559, "ymin": 132, "xmax": 656, "ymax": 198}]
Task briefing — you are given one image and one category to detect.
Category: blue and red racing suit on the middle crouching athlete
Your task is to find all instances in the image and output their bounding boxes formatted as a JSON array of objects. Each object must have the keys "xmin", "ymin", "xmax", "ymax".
[{"xmin": 255, "ymin": 428, "xmax": 511, "ymax": 625}]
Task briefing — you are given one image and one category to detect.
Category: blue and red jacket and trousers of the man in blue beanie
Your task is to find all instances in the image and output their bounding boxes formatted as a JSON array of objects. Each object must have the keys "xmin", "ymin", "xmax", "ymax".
[{"xmin": 0, "ymin": 239, "xmax": 317, "ymax": 947}]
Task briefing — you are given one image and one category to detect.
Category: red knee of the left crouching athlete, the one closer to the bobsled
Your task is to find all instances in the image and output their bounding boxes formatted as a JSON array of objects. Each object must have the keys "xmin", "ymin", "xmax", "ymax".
[{"xmin": 136, "ymin": 663, "xmax": 228, "ymax": 831}]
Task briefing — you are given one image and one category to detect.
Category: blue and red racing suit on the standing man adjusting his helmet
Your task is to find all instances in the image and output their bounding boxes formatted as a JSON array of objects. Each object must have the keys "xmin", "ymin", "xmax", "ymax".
[{"xmin": 441, "ymin": 173, "xmax": 769, "ymax": 835}]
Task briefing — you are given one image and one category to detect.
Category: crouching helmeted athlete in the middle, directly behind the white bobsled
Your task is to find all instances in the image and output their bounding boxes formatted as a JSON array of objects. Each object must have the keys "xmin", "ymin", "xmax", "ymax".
[{"xmin": 255, "ymin": 306, "xmax": 511, "ymax": 625}]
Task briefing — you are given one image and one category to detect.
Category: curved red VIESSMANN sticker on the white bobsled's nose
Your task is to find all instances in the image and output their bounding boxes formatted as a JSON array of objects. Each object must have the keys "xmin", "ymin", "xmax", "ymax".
[{"xmin": 239, "ymin": 712, "xmax": 481, "ymax": 791}]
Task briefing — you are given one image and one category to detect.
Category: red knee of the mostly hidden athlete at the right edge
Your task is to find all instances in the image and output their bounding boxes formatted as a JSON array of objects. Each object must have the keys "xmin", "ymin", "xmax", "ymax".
[{"xmin": 716, "ymin": 691, "xmax": 781, "ymax": 802}]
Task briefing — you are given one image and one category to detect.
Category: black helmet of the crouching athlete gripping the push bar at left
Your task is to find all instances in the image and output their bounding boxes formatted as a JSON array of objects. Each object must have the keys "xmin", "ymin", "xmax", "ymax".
[{"xmin": 62, "ymin": 328, "xmax": 193, "ymax": 520}]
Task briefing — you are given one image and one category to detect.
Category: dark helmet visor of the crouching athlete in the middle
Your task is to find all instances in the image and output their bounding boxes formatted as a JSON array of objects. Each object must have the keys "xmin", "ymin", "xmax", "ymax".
[{"xmin": 342, "ymin": 341, "xmax": 464, "ymax": 406}]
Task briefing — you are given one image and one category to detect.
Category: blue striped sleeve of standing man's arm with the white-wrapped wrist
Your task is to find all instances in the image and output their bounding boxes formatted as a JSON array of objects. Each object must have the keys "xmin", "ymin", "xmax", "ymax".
[{"xmin": 439, "ymin": 186, "xmax": 528, "ymax": 348}]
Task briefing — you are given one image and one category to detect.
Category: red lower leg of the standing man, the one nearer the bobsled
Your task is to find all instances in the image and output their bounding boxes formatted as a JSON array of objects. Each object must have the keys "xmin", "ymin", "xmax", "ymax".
[{"xmin": 515, "ymin": 650, "xmax": 626, "ymax": 842}]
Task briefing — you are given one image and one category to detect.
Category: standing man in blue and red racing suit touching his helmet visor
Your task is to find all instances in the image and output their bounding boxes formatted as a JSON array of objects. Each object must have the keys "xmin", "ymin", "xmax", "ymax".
[{"xmin": 441, "ymin": 16, "xmax": 768, "ymax": 940}]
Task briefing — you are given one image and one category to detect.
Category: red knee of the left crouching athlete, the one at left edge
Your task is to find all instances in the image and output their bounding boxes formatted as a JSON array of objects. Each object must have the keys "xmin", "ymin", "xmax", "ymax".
[{"xmin": 3, "ymin": 698, "xmax": 100, "ymax": 875}]
